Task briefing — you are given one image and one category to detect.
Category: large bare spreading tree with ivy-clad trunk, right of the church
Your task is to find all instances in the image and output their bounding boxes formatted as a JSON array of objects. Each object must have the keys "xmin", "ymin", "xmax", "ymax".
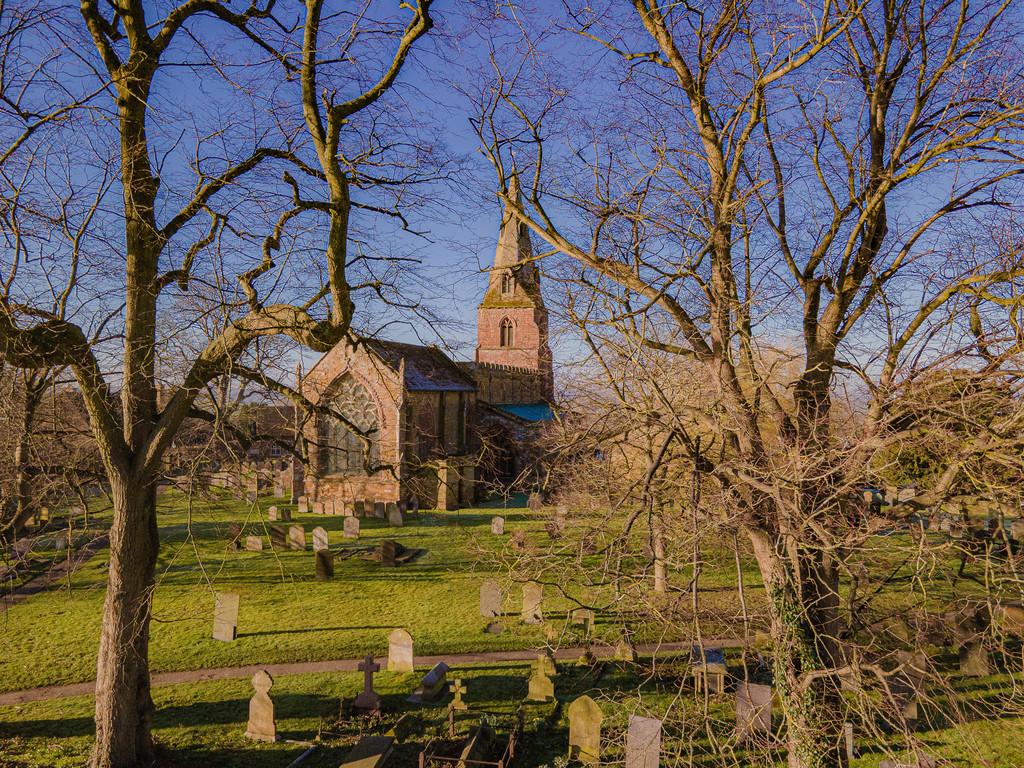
[{"xmin": 477, "ymin": 0, "xmax": 1024, "ymax": 768}]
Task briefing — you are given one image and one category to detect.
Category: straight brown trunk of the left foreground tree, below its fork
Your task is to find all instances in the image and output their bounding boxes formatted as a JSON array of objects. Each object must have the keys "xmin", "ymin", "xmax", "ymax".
[{"xmin": 92, "ymin": 477, "xmax": 159, "ymax": 768}]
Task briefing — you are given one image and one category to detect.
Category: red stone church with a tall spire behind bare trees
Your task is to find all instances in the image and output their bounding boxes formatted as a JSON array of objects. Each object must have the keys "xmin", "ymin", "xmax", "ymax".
[{"xmin": 302, "ymin": 187, "xmax": 553, "ymax": 509}]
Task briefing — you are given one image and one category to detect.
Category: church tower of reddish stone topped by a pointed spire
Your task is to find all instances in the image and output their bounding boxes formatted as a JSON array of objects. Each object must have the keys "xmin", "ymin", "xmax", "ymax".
[{"xmin": 476, "ymin": 176, "xmax": 554, "ymax": 398}]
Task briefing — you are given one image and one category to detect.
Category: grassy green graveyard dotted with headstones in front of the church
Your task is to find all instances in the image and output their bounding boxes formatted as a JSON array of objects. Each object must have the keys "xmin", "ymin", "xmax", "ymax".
[{"xmin": 0, "ymin": 489, "xmax": 1024, "ymax": 768}]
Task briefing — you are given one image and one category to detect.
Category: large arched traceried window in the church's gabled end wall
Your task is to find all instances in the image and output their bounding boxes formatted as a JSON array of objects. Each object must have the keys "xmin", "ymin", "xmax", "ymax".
[{"xmin": 325, "ymin": 374, "xmax": 380, "ymax": 474}]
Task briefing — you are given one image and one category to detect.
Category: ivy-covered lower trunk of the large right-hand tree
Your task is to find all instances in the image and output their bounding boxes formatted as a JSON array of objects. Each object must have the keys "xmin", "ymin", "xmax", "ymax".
[{"xmin": 751, "ymin": 532, "xmax": 847, "ymax": 768}]
